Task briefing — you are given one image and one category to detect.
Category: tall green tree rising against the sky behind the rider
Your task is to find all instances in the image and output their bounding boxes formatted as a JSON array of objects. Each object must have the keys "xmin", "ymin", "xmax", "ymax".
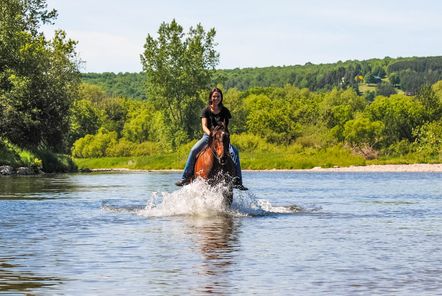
[{"xmin": 141, "ymin": 20, "xmax": 219, "ymax": 146}]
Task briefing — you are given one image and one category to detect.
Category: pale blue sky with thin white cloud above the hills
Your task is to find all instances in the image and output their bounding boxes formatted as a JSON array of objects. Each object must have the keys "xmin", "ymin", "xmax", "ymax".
[{"xmin": 43, "ymin": 0, "xmax": 442, "ymax": 73}]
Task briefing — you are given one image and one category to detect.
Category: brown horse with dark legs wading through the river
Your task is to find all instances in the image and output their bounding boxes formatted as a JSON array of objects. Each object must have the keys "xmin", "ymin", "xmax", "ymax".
[{"xmin": 192, "ymin": 124, "xmax": 235, "ymax": 207}]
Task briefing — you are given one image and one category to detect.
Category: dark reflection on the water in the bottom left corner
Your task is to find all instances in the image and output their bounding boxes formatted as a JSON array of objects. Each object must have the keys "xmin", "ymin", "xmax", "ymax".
[{"xmin": 0, "ymin": 258, "xmax": 62, "ymax": 294}]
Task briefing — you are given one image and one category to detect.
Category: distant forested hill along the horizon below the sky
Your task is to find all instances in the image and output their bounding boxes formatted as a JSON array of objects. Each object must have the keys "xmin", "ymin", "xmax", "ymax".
[{"xmin": 82, "ymin": 56, "xmax": 442, "ymax": 99}]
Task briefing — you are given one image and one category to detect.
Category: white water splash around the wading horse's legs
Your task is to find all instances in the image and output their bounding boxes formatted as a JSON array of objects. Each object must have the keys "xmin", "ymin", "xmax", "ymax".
[{"xmin": 137, "ymin": 180, "xmax": 300, "ymax": 217}]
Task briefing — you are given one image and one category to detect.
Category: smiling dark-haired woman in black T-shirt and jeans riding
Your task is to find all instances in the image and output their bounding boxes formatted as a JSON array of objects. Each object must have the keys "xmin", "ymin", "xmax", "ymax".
[{"xmin": 175, "ymin": 87, "xmax": 248, "ymax": 190}]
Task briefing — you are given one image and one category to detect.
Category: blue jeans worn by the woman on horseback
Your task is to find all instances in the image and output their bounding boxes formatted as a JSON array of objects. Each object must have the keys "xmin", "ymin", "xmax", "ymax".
[{"xmin": 183, "ymin": 134, "xmax": 242, "ymax": 184}]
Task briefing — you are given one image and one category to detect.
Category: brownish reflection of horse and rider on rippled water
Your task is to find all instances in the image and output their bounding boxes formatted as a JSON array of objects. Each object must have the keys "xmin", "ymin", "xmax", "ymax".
[{"xmin": 190, "ymin": 215, "xmax": 239, "ymax": 294}]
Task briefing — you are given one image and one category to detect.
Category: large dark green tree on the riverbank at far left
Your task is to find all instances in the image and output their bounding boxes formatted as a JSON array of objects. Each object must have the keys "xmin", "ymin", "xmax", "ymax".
[{"xmin": 0, "ymin": 0, "xmax": 79, "ymax": 151}]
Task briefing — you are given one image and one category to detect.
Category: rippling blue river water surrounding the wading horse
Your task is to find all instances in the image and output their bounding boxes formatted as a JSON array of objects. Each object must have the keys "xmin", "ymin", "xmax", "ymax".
[{"xmin": 0, "ymin": 172, "xmax": 442, "ymax": 295}]
